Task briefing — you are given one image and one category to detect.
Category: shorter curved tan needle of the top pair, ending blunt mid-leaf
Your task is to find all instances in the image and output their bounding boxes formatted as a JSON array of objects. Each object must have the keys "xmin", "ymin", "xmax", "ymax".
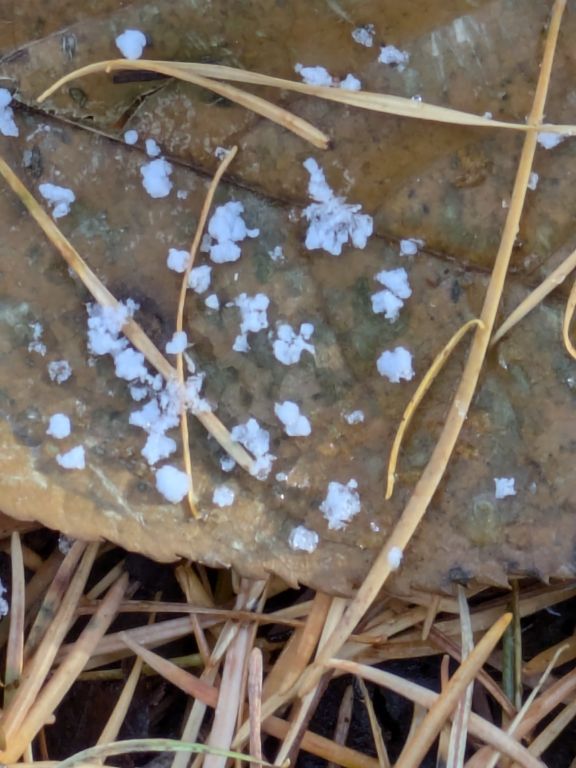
[{"xmin": 38, "ymin": 59, "xmax": 329, "ymax": 149}]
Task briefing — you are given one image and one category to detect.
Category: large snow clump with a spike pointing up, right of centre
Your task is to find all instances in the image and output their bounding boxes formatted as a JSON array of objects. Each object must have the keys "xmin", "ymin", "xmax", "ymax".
[{"xmin": 303, "ymin": 158, "xmax": 373, "ymax": 256}]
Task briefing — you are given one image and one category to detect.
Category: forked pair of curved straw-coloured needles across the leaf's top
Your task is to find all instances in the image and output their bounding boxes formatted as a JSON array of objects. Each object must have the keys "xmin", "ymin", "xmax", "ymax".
[{"xmin": 38, "ymin": 59, "xmax": 576, "ymax": 136}]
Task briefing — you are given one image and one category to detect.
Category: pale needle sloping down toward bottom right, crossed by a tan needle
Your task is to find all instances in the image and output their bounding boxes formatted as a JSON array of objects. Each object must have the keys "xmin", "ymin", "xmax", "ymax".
[{"xmin": 328, "ymin": 659, "xmax": 546, "ymax": 768}]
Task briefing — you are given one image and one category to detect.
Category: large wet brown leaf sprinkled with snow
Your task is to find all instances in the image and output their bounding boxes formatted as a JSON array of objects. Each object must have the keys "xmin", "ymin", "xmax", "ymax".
[{"xmin": 0, "ymin": 1, "xmax": 576, "ymax": 593}]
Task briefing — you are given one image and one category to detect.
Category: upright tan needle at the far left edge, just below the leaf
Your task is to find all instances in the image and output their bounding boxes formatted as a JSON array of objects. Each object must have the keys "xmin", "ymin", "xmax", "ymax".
[{"xmin": 4, "ymin": 531, "xmax": 26, "ymax": 709}]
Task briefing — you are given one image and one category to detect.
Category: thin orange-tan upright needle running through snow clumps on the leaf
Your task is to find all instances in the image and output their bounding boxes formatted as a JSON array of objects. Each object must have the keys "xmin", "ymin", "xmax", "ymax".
[{"xmin": 176, "ymin": 147, "xmax": 238, "ymax": 517}]
